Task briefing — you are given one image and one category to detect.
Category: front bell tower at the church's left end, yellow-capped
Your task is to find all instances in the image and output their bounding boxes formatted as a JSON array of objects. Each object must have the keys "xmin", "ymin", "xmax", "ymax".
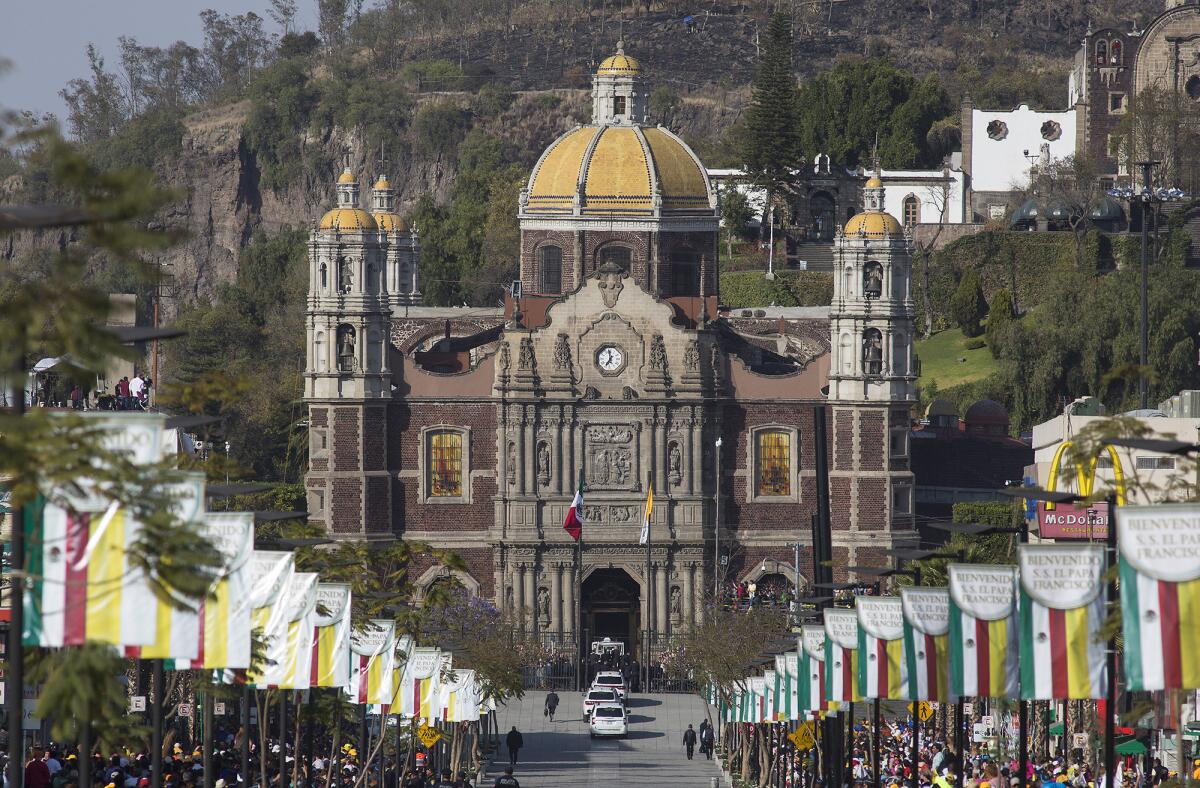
[{"xmin": 304, "ymin": 167, "xmax": 398, "ymax": 536}]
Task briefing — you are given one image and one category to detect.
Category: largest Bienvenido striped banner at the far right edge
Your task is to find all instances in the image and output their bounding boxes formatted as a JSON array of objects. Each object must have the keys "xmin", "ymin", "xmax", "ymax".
[{"xmin": 1116, "ymin": 504, "xmax": 1200, "ymax": 692}]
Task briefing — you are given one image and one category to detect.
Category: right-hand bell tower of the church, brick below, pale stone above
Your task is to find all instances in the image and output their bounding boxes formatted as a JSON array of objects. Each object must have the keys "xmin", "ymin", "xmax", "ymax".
[{"xmin": 829, "ymin": 172, "xmax": 917, "ymax": 564}]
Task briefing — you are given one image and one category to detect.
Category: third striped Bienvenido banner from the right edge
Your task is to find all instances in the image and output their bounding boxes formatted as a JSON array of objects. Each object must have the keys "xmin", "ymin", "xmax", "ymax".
[{"xmin": 948, "ymin": 564, "xmax": 1020, "ymax": 698}]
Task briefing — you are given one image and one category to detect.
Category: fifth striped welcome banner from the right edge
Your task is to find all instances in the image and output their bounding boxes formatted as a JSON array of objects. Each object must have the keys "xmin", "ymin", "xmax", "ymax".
[{"xmin": 854, "ymin": 596, "xmax": 908, "ymax": 700}]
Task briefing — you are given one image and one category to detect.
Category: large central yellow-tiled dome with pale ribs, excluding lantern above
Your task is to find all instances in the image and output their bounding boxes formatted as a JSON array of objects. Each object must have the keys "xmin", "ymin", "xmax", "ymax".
[{"xmin": 526, "ymin": 126, "xmax": 713, "ymax": 216}]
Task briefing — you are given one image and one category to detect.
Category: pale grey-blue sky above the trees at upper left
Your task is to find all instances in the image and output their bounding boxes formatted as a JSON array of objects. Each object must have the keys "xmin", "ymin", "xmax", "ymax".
[{"xmin": 0, "ymin": 0, "xmax": 317, "ymax": 120}]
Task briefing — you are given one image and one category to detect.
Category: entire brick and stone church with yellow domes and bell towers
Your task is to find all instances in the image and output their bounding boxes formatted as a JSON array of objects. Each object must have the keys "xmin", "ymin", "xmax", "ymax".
[{"xmin": 305, "ymin": 46, "xmax": 916, "ymax": 648}]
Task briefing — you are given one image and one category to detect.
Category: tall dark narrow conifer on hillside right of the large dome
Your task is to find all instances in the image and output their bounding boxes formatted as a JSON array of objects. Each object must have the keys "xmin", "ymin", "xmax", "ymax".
[{"xmin": 742, "ymin": 13, "xmax": 802, "ymax": 196}]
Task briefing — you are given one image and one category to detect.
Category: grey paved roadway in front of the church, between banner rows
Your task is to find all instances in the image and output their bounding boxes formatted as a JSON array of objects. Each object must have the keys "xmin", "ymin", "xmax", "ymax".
[{"xmin": 484, "ymin": 691, "xmax": 720, "ymax": 788}]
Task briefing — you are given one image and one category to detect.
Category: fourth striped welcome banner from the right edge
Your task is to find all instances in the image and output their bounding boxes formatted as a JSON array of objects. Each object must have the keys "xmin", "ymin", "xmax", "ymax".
[{"xmin": 900, "ymin": 587, "xmax": 950, "ymax": 700}]
